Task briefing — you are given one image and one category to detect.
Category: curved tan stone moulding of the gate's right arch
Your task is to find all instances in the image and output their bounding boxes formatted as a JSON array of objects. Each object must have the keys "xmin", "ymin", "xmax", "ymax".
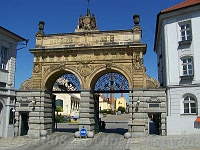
[{"xmin": 86, "ymin": 65, "xmax": 133, "ymax": 89}]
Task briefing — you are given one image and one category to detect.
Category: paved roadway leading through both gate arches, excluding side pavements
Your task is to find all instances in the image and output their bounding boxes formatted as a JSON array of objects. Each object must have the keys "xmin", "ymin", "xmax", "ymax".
[{"xmin": 27, "ymin": 115, "xmax": 129, "ymax": 150}]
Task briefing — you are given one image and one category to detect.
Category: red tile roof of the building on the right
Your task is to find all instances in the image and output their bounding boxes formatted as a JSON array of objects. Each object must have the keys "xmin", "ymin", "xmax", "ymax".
[{"xmin": 161, "ymin": 0, "xmax": 200, "ymax": 13}]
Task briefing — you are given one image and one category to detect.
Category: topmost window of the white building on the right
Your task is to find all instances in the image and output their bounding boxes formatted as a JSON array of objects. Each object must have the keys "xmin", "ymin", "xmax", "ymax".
[{"xmin": 180, "ymin": 22, "xmax": 192, "ymax": 41}]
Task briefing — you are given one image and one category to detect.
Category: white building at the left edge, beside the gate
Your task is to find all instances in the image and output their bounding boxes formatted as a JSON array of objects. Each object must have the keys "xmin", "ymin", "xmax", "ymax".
[{"xmin": 0, "ymin": 26, "xmax": 26, "ymax": 138}]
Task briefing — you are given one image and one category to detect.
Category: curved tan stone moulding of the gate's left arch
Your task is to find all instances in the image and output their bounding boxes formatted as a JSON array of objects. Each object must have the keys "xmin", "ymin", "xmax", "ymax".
[{"xmin": 42, "ymin": 69, "xmax": 83, "ymax": 91}]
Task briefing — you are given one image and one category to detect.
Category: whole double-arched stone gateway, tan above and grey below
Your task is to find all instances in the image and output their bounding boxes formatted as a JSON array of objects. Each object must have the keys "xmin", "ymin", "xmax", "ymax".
[{"xmin": 16, "ymin": 15, "xmax": 166, "ymax": 137}]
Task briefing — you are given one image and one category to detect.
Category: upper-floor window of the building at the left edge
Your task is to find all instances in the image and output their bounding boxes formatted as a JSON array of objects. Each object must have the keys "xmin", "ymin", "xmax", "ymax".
[{"xmin": 0, "ymin": 47, "xmax": 8, "ymax": 69}]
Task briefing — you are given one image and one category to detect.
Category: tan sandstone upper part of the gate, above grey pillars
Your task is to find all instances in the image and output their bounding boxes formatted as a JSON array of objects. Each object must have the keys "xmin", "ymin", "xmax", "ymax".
[{"xmin": 24, "ymin": 15, "xmax": 158, "ymax": 90}]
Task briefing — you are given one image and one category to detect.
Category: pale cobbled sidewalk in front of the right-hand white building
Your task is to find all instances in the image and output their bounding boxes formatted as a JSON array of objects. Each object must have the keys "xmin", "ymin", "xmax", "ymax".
[{"xmin": 126, "ymin": 135, "xmax": 200, "ymax": 150}]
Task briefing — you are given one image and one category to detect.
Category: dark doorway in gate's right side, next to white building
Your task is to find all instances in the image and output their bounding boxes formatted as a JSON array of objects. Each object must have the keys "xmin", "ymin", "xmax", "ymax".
[{"xmin": 148, "ymin": 113, "xmax": 161, "ymax": 135}]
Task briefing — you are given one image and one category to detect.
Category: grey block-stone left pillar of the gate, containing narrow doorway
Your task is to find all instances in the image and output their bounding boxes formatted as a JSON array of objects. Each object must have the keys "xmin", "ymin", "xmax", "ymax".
[{"xmin": 15, "ymin": 90, "xmax": 55, "ymax": 138}]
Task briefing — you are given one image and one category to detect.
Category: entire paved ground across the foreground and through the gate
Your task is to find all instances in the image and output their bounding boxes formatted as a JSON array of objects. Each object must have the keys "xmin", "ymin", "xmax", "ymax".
[{"xmin": 0, "ymin": 115, "xmax": 200, "ymax": 150}]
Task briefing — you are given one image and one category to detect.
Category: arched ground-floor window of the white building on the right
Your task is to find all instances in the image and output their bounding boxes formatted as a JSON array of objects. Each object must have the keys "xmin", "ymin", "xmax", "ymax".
[{"xmin": 183, "ymin": 96, "xmax": 197, "ymax": 114}]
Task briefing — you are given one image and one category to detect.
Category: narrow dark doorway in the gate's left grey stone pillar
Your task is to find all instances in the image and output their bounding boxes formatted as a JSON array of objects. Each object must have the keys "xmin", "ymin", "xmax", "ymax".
[{"xmin": 21, "ymin": 112, "xmax": 29, "ymax": 136}]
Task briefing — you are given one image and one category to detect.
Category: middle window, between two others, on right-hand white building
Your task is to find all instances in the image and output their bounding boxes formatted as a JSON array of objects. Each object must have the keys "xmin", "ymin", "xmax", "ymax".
[{"xmin": 182, "ymin": 58, "xmax": 193, "ymax": 76}]
